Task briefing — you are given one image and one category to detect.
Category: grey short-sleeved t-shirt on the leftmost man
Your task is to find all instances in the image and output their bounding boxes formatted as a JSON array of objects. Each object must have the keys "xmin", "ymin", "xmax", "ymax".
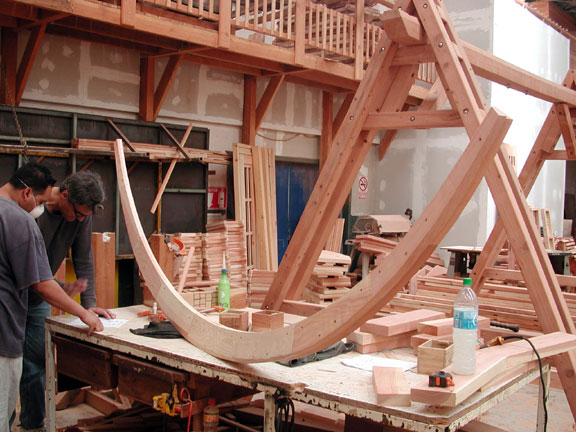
[{"xmin": 0, "ymin": 197, "xmax": 52, "ymax": 357}]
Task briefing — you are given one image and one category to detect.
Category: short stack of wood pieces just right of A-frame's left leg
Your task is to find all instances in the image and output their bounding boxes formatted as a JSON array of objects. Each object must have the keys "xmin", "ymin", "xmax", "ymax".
[{"xmin": 303, "ymin": 250, "xmax": 351, "ymax": 304}]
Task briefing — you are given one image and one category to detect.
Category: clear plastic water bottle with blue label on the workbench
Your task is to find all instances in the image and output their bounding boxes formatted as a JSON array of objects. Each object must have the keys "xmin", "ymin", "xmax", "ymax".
[{"xmin": 452, "ymin": 278, "xmax": 478, "ymax": 375}]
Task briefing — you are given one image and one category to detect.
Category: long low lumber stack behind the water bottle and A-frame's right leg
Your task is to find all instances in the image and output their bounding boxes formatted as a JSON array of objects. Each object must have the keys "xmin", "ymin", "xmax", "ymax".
[{"xmin": 385, "ymin": 276, "xmax": 576, "ymax": 331}]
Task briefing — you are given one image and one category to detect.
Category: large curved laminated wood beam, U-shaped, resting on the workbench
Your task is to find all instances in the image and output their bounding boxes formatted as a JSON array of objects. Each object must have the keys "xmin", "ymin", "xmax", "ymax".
[{"xmin": 114, "ymin": 109, "xmax": 511, "ymax": 362}]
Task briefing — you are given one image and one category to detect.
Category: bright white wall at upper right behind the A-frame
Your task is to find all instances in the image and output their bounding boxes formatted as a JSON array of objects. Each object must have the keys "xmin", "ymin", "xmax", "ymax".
[{"xmin": 492, "ymin": 1, "xmax": 570, "ymax": 235}]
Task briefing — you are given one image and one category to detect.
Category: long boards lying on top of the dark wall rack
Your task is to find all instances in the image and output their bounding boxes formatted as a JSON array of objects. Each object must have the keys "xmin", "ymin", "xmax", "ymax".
[{"xmin": 72, "ymin": 139, "xmax": 232, "ymax": 165}]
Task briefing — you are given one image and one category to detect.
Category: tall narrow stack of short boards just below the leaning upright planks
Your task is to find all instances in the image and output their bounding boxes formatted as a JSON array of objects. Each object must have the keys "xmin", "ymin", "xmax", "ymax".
[{"xmin": 206, "ymin": 220, "xmax": 248, "ymax": 288}]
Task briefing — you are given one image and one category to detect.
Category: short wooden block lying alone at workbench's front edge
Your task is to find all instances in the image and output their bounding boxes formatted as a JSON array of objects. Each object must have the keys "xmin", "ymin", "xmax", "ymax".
[{"xmin": 372, "ymin": 366, "xmax": 411, "ymax": 406}]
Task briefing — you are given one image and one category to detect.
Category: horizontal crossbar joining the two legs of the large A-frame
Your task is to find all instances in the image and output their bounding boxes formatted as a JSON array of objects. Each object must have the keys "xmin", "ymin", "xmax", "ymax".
[{"xmin": 364, "ymin": 110, "xmax": 464, "ymax": 130}]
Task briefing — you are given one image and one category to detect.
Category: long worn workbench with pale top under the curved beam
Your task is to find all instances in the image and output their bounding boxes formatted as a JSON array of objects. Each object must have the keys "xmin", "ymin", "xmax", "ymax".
[{"xmin": 46, "ymin": 306, "xmax": 537, "ymax": 432}]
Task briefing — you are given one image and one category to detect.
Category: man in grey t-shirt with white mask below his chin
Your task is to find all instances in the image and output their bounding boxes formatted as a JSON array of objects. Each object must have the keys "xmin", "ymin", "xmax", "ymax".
[{"xmin": 0, "ymin": 163, "xmax": 103, "ymax": 431}]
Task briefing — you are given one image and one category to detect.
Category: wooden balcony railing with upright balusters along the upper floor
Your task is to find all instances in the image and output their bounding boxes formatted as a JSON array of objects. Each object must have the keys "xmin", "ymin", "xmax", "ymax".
[{"xmin": 134, "ymin": 0, "xmax": 436, "ymax": 83}]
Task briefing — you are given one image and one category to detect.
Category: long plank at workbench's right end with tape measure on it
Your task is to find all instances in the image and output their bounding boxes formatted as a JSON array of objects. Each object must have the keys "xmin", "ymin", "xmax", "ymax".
[{"xmin": 411, "ymin": 332, "xmax": 576, "ymax": 407}]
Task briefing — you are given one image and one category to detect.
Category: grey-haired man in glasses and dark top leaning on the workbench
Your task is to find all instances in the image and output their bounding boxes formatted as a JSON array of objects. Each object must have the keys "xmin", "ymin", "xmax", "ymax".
[{"xmin": 20, "ymin": 171, "xmax": 115, "ymax": 431}]
